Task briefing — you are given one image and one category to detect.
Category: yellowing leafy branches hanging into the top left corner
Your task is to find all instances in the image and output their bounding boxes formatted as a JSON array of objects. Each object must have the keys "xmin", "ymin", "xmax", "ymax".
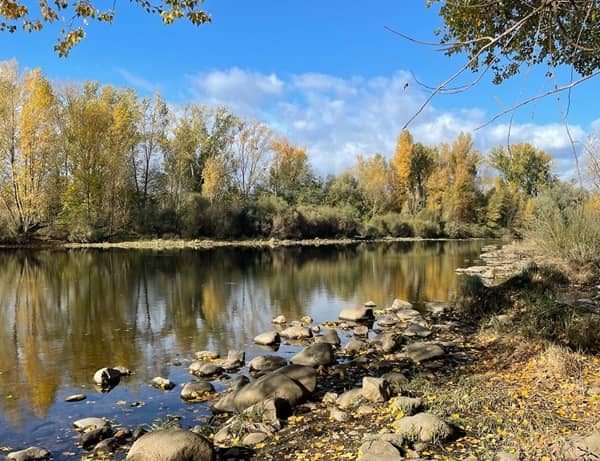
[{"xmin": 0, "ymin": 0, "xmax": 210, "ymax": 57}]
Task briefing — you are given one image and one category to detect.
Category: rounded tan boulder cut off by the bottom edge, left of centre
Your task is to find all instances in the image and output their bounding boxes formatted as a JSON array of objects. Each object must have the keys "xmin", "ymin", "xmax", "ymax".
[{"xmin": 127, "ymin": 429, "xmax": 215, "ymax": 461}]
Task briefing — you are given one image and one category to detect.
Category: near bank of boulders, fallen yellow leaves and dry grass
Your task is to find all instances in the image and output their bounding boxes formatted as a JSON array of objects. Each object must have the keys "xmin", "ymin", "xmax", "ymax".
[{"xmin": 10, "ymin": 274, "xmax": 600, "ymax": 461}]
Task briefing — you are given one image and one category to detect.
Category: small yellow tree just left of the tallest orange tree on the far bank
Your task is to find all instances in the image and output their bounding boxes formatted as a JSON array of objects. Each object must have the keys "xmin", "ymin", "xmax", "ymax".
[{"xmin": 355, "ymin": 154, "xmax": 392, "ymax": 217}]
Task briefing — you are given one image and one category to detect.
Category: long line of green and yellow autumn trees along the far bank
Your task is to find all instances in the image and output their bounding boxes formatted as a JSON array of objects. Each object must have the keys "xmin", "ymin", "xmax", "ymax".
[{"xmin": 0, "ymin": 61, "xmax": 557, "ymax": 241}]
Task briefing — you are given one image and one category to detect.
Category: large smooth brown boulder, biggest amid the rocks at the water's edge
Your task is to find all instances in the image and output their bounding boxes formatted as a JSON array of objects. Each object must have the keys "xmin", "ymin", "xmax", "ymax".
[{"xmin": 233, "ymin": 365, "xmax": 317, "ymax": 411}]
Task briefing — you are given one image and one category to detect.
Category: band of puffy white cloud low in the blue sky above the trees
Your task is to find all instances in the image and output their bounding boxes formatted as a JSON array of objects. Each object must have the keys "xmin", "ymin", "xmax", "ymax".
[{"xmin": 182, "ymin": 67, "xmax": 600, "ymax": 173}]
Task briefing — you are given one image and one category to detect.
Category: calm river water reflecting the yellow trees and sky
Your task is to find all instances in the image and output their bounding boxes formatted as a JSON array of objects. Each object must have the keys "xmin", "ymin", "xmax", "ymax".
[{"xmin": 0, "ymin": 241, "xmax": 484, "ymax": 452}]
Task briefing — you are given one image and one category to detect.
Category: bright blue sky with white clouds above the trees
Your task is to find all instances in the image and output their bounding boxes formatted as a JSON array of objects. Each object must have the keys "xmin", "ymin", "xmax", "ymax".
[{"xmin": 0, "ymin": 0, "xmax": 600, "ymax": 176}]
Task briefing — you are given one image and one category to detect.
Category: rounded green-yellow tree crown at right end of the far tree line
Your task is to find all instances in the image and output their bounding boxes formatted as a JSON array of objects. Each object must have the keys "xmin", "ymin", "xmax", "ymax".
[{"xmin": 489, "ymin": 143, "xmax": 554, "ymax": 197}]
